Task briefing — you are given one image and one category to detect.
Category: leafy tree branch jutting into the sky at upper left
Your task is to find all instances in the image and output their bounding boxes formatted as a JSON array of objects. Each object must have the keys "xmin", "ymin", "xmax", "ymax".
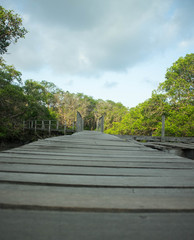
[{"xmin": 0, "ymin": 6, "xmax": 27, "ymax": 54}]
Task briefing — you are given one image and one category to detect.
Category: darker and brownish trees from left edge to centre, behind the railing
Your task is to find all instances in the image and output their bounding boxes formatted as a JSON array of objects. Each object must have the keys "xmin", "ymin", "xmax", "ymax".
[{"xmin": 0, "ymin": 61, "xmax": 128, "ymax": 139}]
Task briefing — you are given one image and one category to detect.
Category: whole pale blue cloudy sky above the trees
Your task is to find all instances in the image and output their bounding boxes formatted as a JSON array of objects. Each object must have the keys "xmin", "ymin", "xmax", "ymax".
[{"xmin": 1, "ymin": 0, "xmax": 194, "ymax": 108}]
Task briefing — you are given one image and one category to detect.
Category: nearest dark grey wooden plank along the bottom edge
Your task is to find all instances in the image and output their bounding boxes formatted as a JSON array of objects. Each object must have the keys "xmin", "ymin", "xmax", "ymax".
[{"xmin": 0, "ymin": 209, "xmax": 194, "ymax": 240}]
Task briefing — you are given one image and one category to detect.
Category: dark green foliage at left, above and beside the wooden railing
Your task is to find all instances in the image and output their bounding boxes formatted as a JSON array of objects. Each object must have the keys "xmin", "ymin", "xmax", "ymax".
[{"xmin": 0, "ymin": 69, "xmax": 56, "ymax": 139}]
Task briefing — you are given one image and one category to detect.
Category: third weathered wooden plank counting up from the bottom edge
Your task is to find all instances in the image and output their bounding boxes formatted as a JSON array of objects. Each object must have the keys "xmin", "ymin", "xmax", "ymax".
[{"xmin": 0, "ymin": 172, "xmax": 194, "ymax": 188}]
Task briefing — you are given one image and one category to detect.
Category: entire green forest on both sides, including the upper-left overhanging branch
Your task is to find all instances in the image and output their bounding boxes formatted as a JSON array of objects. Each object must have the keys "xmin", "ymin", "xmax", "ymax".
[{"xmin": 0, "ymin": 7, "xmax": 194, "ymax": 141}]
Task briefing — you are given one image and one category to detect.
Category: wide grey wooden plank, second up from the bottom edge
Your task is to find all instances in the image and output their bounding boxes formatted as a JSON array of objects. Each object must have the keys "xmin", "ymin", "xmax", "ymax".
[{"xmin": 0, "ymin": 184, "xmax": 194, "ymax": 212}]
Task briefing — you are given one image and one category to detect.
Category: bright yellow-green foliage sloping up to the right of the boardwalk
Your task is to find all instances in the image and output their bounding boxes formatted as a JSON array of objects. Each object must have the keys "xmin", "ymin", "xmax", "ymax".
[{"xmin": 106, "ymin": 53, "xmax": 194, "ymax": 137}]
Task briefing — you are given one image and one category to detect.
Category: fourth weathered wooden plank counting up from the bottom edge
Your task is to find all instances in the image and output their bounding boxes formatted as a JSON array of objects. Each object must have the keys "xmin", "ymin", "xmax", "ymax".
[{"xmin": 0, "ymin": 163, "xmax": 193, "ymax": 177}]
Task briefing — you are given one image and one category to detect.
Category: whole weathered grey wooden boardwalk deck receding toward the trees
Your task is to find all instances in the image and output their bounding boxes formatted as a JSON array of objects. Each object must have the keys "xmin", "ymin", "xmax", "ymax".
[{"xmin": 0, "ymin": 131, "xmax": 194, "ymax": 240}]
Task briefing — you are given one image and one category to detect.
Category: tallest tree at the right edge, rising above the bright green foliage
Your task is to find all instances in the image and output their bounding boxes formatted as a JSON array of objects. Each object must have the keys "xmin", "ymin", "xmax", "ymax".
[{"xmin": 158, "ymin": 53, "xmax": 194, "ymax": 137}]
